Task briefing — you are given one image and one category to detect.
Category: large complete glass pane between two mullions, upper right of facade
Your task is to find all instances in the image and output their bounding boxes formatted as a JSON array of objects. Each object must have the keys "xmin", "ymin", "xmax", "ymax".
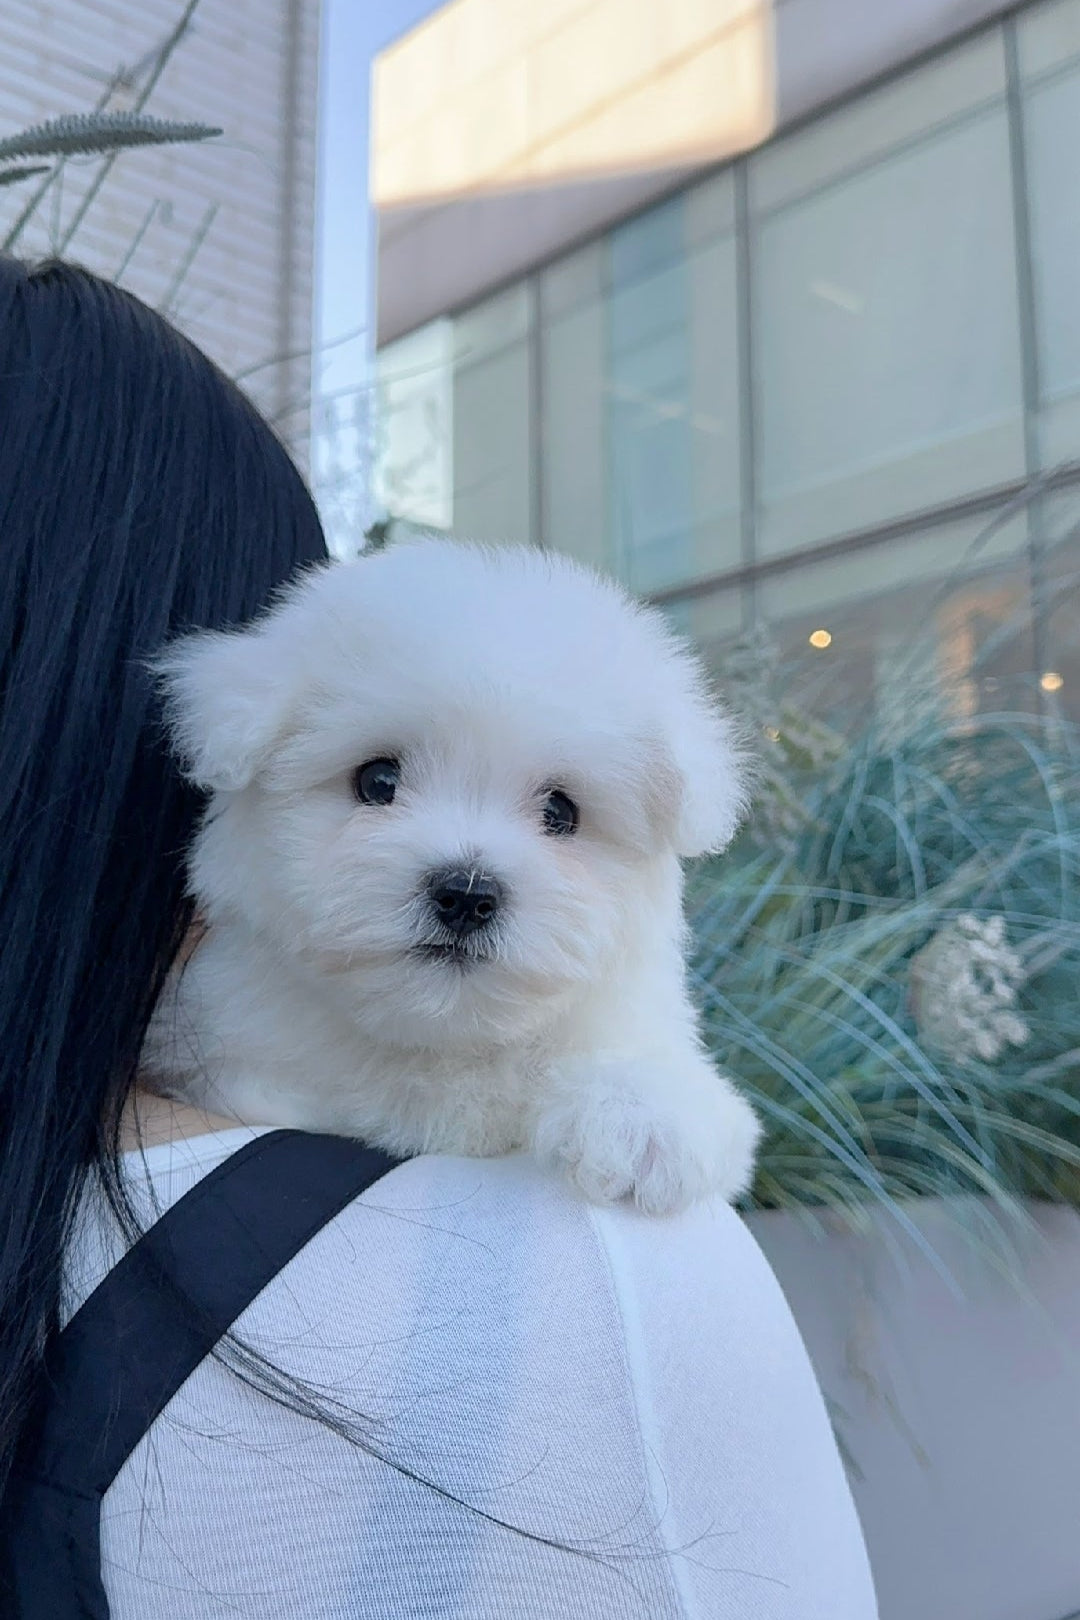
[{"xmin": 753, "ymin": 87, "xmax": 1023, "ymax": 557}]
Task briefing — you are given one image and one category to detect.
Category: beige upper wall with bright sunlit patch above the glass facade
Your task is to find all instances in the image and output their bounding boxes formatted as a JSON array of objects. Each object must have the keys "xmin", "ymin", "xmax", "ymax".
[{"xmin": 371, "ymin": 0, "xmax": 1015, "ymax": 345}]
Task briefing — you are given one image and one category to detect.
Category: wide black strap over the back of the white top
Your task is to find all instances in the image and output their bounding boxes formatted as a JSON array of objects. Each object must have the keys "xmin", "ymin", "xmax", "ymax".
[{"xmin": 3, "ymin": 1131, "xmax": 400, "ymax": 1620}]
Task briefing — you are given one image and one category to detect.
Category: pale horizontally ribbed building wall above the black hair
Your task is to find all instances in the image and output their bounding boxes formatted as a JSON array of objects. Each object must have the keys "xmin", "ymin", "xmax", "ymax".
[{"xmin": 0, "ymin": 0, "xmax": 319, "ymax": 452}]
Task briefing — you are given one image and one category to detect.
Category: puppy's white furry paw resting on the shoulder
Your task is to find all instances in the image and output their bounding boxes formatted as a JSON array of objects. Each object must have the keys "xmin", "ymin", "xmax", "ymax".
[{"xmin": 533, "ymin": 1059, "xmax": 759, "ymax": 1215}]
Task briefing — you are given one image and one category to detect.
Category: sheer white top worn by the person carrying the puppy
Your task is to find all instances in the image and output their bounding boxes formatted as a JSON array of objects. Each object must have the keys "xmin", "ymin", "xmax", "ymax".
[{"xmin": 61, "ymin": 1128, "xmax": 876, "ymax": 1620}]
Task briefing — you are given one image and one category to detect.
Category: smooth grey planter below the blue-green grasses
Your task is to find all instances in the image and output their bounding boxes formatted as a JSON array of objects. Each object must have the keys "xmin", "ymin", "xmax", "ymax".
[{"xmin": 750, "ymin": 1199, "xmax": 1080, "ymax": 1620}]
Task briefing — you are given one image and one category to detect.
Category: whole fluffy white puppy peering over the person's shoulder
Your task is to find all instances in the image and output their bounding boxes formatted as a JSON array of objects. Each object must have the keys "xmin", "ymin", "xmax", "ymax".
[{"xmin": 146, "ymin": 541, "xmax": 758, "ymax": 1213}]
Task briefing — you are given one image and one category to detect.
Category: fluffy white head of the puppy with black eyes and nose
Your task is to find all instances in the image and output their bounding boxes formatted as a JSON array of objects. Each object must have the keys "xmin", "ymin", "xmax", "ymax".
[{"xmin": 160, "ymin": 541, "xmax": 743, "ymax": 1045}]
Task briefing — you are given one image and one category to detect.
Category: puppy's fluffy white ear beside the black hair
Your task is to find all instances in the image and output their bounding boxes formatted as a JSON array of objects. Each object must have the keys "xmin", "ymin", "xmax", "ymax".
[{"xmin": 152, "ymin": 619, "xmax": 293, "ymax": 791}]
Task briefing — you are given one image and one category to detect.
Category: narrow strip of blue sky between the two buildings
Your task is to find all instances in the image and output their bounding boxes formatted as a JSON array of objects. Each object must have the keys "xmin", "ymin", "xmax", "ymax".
[{"xmin": 316, "ymin": 0, "xmax": 439, "ymax": 411}]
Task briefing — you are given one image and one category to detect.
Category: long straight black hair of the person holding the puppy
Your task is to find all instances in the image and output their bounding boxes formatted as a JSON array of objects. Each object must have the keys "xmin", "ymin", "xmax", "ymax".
[{"xmin": 0, "ymin": 258, "xmax": 325, "ymax": 1494}]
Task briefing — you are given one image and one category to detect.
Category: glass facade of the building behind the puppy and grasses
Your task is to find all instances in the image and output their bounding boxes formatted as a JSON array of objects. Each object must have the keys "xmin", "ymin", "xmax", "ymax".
[{"xmin": 379, "ymin": 0, "xmax": 1080, "ymax": 713}]
